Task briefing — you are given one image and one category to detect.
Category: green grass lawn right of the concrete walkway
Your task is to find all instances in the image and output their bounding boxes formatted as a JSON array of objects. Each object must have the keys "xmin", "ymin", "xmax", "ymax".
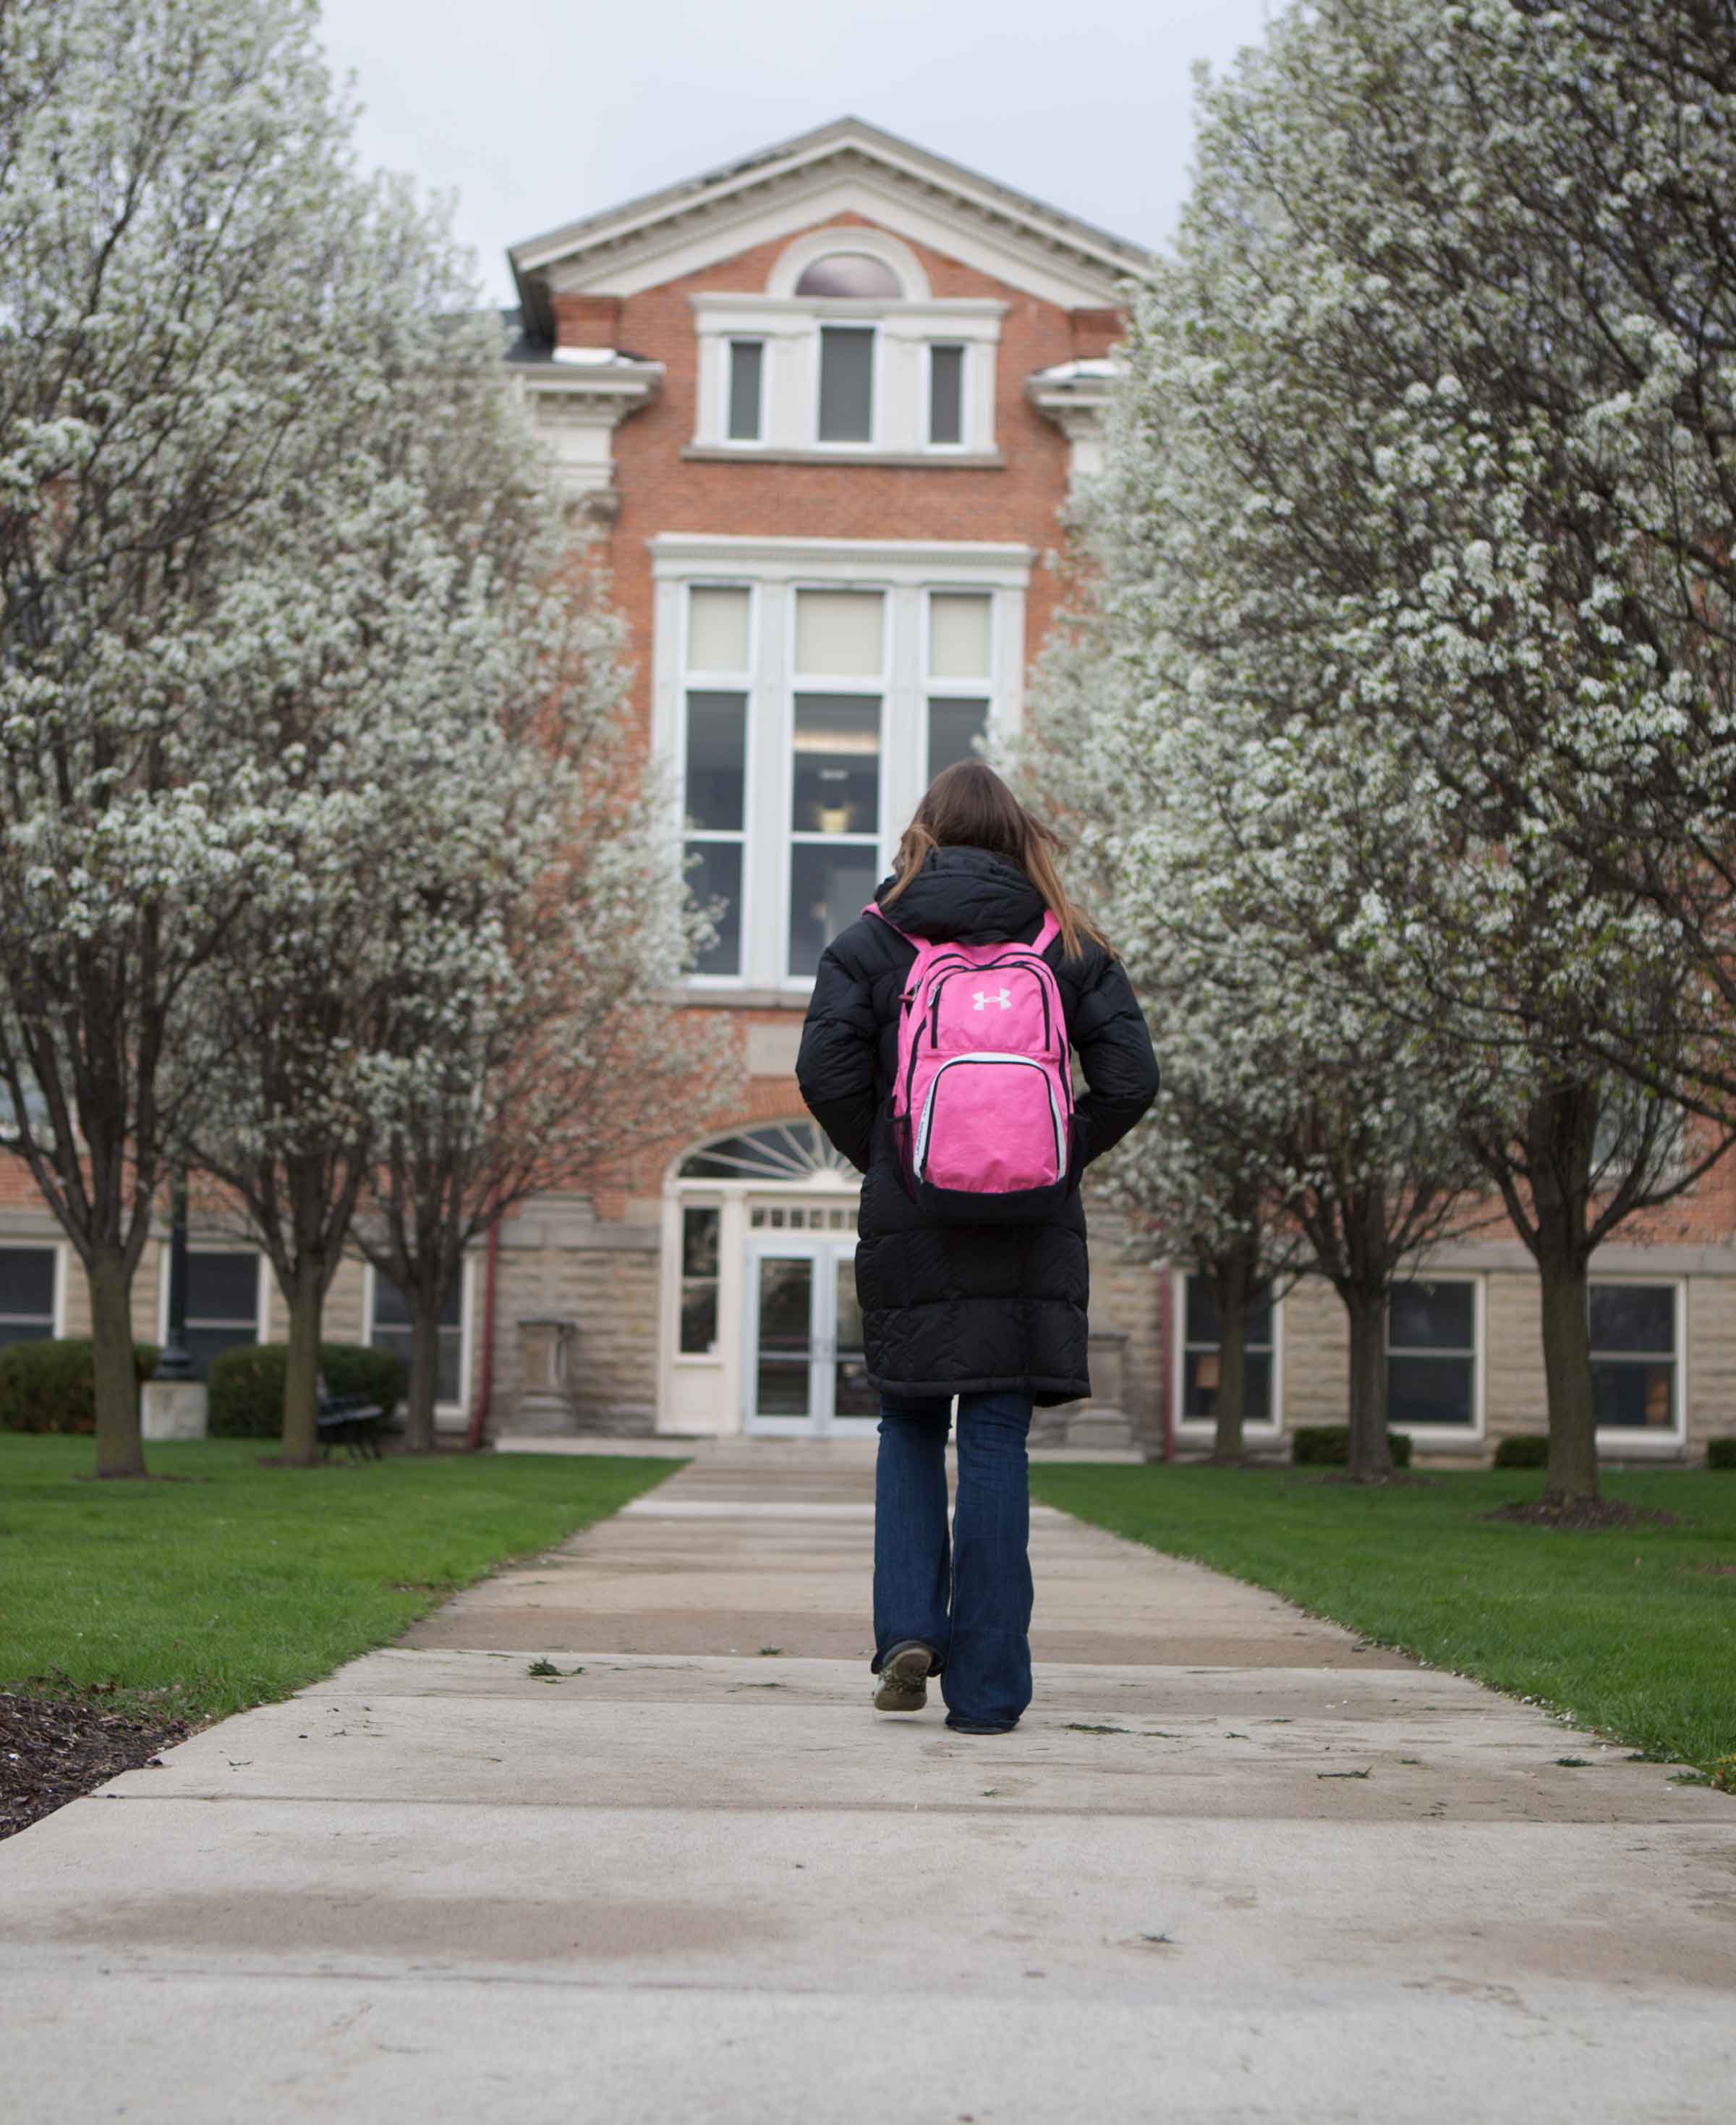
[{"xmin": 1031, "ymin": 1462, "xmax": 1736, "ymax": 1781}]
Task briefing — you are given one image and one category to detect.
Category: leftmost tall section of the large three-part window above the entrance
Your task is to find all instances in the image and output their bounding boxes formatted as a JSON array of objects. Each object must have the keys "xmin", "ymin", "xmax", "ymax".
[{"xmin": 682, "ymin": 585, "xmax": 752, "ymax": 975}]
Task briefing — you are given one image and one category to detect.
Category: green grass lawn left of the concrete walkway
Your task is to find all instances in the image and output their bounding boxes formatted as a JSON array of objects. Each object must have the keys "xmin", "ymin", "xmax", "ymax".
[{"xmin": 0, "ymin": 1433, "xmax": 680, "ymax": 1719}]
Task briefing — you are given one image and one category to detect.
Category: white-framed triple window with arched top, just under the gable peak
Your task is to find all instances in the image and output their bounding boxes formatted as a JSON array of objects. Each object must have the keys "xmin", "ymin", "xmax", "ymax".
[{"xmin": 691, "ymin": 225, "xmax": 1007, "ymax": 465}]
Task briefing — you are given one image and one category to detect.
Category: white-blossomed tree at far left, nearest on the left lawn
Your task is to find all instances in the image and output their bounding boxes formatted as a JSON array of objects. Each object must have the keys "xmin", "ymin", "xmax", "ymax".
[{"xmin": 0, "ymin": 0, "xmax": 378, "ymax": 1475}]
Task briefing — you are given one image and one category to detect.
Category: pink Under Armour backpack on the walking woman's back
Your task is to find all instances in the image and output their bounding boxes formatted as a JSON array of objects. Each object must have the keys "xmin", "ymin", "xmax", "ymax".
[{"xmin": 863, "ymin": 903, "xmax": 1073, "ymax": 1224}]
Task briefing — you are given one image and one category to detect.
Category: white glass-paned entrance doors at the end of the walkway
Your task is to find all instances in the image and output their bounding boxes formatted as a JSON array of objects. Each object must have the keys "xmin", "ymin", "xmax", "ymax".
[{"xmin": 741, "ymin": 1232, "xmax": 880, "ymax": 1438}]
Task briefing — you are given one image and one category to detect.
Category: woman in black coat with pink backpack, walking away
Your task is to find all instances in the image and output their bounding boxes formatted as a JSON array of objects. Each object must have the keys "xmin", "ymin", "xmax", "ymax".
[{"xmin": 797, "ymin": 760, "xmax": 1158, "ymax": 1734}]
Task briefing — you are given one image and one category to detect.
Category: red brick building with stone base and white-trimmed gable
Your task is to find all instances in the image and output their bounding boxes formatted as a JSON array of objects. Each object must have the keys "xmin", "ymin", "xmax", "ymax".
[{"xmin": 0, "ymin": 119, "xmax": 1736, "ymax": 1458}]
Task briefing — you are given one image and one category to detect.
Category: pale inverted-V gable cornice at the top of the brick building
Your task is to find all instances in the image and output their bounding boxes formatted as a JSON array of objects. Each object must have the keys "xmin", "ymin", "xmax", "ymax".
[{"xmin": 510, "ymin": 119, "xmax": 1149, "ymax": 329}]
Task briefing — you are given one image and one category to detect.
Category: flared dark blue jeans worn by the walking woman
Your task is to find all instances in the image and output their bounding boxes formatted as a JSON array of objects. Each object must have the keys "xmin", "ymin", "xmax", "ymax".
[{"xmin": 873, "ymin": 1394, "xmax": 1031, "ymax": 1728}]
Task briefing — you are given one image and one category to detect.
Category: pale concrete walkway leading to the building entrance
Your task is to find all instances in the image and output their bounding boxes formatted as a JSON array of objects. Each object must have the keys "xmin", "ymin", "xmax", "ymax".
[{"xmin": 0, "ymin": 1443, "xmax": 1736, "ymax": 2125}]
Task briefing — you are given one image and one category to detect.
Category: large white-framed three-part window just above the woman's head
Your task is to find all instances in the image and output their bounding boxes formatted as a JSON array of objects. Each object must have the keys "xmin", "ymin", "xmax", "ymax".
[{"xmin": 678, "ymin": 582, "xmax": 997, "ymax": 986}]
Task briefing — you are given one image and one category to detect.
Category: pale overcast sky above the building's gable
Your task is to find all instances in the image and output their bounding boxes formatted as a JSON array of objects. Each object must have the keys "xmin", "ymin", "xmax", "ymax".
[{"xmin": 314, "ymin": 0, "xmax": 1275, "ymax": 302}]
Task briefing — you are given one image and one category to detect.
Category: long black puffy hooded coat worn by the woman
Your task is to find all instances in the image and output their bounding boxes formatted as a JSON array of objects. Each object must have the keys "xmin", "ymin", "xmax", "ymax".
[{"xmin": 795, "ymin": 848, "xmax": 1158, "ymax": 1402}]
